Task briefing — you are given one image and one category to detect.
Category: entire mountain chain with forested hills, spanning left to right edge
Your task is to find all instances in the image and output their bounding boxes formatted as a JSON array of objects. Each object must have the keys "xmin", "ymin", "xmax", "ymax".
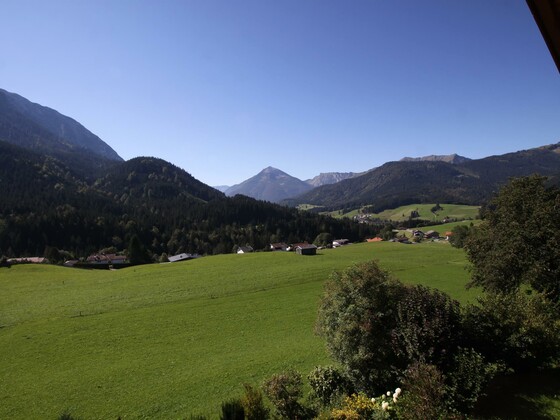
[{"xmin": 0, "ymin": 89, "xmax": 560, "ymax": 255}]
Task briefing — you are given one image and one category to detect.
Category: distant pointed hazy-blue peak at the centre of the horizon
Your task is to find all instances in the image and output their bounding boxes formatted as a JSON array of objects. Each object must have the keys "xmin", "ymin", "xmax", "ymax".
[{"xmin": 225, "ymin": 166, "xmax": 312, "ymax": 203}]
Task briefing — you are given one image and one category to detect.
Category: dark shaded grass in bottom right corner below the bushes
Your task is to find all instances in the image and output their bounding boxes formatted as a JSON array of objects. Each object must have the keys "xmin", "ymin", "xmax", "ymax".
[{"xmin": 474, "ymin": 368, "xmax": 560, "ymax": 420}]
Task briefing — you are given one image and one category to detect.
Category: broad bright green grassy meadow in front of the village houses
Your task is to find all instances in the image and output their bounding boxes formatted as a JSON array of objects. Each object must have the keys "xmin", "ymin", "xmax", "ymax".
[{"xmin": 0, "ymin": 243, "xmax": 556, "ymax": 419}]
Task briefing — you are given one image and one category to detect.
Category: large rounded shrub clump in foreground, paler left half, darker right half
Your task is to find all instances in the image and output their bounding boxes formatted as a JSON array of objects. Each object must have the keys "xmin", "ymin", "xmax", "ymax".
[{"xmin": 317, "ymin": 261, "xmax": 462, "ymax": 395}]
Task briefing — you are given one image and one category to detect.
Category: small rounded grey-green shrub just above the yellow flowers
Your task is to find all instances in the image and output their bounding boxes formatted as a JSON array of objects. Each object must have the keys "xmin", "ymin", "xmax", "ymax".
[{"xmin": 307, "ymin": 366, "xmax": 351, "ymax": 406}]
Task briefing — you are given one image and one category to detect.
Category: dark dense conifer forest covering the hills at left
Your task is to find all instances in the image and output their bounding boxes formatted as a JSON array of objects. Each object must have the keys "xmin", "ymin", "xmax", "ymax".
[{"xmin": 0, "ymin": 142, "xmax": 377, "ymax": 259}]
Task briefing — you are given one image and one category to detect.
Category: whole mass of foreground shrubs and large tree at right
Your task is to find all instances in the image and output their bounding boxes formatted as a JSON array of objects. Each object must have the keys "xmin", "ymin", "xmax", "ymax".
[{"xmin": 317, "ymin": 176, "xmax": 560, "ymax": 418}]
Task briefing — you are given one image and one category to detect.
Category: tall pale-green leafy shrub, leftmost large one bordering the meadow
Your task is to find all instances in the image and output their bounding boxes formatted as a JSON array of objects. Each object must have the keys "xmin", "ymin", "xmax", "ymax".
[{"xmin": 317, "ymin": 261, "xmax": 404, "ymax": 395}]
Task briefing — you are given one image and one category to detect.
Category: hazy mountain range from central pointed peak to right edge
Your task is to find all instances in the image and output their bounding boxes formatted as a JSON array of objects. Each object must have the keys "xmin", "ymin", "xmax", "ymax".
[{"xmin": 224, "ymin": 147, "xmax": 560, "ymax": 211}]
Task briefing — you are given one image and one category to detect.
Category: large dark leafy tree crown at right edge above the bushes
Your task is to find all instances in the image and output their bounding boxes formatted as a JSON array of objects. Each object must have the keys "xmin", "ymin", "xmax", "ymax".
[{"xmin": 465, "ymin": 175, "xmax": 560, "ymax": 304}]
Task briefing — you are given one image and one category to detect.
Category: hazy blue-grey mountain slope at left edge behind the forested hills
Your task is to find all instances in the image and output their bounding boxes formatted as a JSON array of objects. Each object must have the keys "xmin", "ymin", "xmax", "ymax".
[{"xmin": 0, "ymin": 89, "xmax": 122, "ymax": 175}]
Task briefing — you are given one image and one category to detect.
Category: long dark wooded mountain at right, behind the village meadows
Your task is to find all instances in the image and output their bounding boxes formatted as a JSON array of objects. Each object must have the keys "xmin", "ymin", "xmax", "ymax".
[{"xmin": 284, "ymin": 143, "xmax": 560, "ymax": 211}]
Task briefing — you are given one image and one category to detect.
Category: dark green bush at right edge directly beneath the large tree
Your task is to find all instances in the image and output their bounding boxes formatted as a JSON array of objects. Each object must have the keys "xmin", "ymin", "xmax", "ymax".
[{"xmin": 465, "ymin": 291, "xmax": 560, "ymax": 372}]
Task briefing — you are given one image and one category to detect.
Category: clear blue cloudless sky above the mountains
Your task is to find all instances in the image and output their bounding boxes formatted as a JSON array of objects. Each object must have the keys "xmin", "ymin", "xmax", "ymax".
[{"xmin": 0, "ymin": 0, "xmax": 560, "ymax": 185}]
